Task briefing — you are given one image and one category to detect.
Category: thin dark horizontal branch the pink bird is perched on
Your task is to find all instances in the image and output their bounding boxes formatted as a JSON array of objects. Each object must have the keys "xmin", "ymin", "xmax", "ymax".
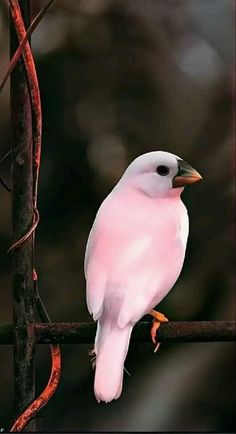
[{"xmin": 0, "ymin": 321, "xmax": 236, "ymax": 345}]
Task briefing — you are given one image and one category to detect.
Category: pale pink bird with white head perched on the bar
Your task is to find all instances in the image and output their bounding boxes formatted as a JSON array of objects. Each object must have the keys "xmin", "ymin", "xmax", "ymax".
[{"xmin": 84, "ymin": 151, "xmax": 202, "ymax": 403}]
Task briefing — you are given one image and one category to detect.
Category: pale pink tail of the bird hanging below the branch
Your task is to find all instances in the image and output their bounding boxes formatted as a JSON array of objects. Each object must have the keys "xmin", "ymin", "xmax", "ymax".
[{"xmin": 94, "ymin": 321, "xmax": 132, "ymax": 402}]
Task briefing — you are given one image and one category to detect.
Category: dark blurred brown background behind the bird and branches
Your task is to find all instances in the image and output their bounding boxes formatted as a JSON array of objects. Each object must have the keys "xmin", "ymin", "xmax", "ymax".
[{"xmin": 0, "ymin": 0, "xmax": 236, "ymax": 432}]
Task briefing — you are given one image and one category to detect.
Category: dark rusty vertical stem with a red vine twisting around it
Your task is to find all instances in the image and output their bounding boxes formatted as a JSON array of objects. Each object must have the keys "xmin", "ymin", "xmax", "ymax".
[{"xmin": 10, "ymin": 0, "xmax": 35, "ymax": 431}]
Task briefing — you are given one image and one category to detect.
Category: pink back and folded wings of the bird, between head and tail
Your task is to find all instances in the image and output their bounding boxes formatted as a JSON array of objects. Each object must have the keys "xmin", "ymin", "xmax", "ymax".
[{"xmin": 85, "ymin": 192, "xmax": 186, "ymax": 327}]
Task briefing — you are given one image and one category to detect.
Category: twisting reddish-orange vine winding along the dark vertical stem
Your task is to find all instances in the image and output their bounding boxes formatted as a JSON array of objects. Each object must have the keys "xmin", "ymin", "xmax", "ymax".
[{"xmin": 9, "ymin": 0, "xmax": 61, "ymax": 432}]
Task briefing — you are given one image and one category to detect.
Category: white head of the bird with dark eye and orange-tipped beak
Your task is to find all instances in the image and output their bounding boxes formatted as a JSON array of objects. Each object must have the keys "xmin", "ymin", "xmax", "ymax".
[{"xmin": 121, "ymin": 151, "xmax": 202, "ymax": 197}]
